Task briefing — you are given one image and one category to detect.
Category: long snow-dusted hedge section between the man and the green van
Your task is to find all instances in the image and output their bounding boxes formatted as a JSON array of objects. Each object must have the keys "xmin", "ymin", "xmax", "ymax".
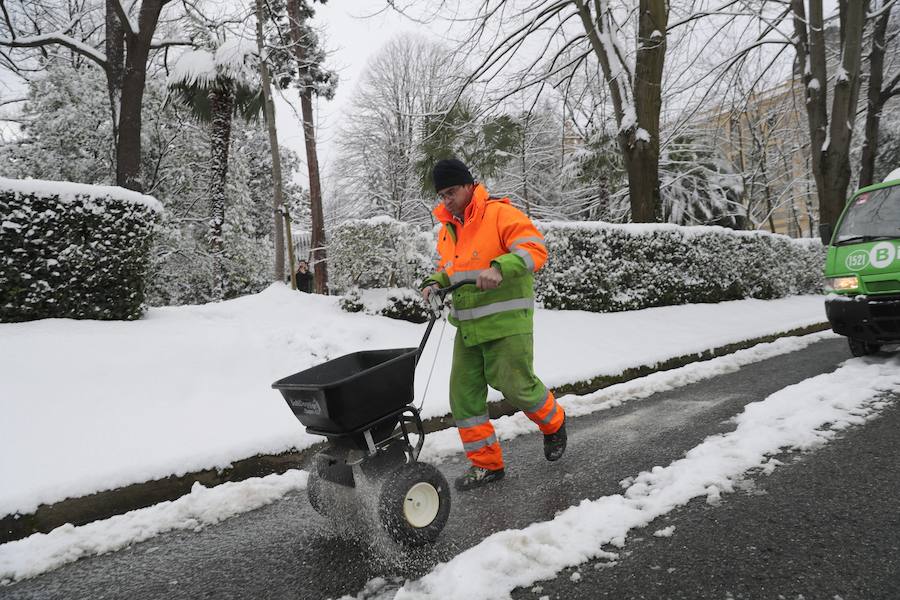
[{"xmin": 535, "ymin": 222, "xmax": 825, "ymax": 312}]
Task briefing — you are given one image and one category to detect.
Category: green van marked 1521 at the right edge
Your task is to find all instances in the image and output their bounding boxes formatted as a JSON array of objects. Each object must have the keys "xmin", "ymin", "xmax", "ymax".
[{"xmin": 822, "ymin": 169, "xmax": 900, "ymax": 356}]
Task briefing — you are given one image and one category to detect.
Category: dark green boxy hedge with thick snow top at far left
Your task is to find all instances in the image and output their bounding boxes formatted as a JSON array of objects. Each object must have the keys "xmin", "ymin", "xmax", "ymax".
[{"xmin": 0, "ymin": 178, "xmax": 163, "ymax": 322}]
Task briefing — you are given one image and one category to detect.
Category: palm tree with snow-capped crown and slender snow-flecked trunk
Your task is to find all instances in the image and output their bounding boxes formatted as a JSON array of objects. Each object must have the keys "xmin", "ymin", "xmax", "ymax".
[{"xmin": 169, "ymin": 40, "xmax": 263, "ymax": 300}]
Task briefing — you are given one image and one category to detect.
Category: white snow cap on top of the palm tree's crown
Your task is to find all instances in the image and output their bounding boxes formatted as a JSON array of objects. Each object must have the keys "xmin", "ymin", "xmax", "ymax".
[{"xmin": 169, "ymin": 38, "xmax": 257, "ymax": 85}]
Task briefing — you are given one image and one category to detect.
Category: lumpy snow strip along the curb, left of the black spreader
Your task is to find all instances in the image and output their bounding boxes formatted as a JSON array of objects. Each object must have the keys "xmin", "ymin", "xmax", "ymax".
[{"xmin": 0, "ymin": 471, "xmax": 308, "ymax": 584}]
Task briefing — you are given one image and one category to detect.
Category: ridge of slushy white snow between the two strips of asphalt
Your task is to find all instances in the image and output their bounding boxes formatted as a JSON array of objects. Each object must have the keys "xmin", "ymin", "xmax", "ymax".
[{"xmin": 384, "ymin": 357, "xmax": 900, "ymax": 600}]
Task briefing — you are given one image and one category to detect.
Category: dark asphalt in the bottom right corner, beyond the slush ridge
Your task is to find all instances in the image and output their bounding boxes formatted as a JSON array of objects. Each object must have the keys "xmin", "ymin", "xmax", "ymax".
[{"xmin": 512, "ymin": 396, "xmax": 900, "ymax": 600}]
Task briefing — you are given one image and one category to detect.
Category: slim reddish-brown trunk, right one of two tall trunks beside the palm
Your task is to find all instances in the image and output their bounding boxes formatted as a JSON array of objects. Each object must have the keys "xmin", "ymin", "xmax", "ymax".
[{"xmin": 287, "ymin": 0, "xmax": 328, "ymax": 294}]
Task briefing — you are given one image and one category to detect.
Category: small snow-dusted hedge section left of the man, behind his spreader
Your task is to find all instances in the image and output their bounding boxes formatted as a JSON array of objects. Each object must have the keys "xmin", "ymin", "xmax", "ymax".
[{"xmin": 328, "ymin": 217, "xmax": 434, "ymax": 293}]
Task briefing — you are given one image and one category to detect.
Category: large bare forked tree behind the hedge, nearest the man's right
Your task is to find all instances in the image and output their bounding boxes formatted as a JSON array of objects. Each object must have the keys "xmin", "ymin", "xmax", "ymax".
[{"xmin": 414, "ymin": 0, "xmax": 669, "ymax": 222}]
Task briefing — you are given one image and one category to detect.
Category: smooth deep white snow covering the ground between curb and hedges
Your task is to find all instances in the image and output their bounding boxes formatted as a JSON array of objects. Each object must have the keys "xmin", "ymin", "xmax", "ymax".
[{"xmin": 0, "ymin": 285, "xmax": 824, "ymax": 515}]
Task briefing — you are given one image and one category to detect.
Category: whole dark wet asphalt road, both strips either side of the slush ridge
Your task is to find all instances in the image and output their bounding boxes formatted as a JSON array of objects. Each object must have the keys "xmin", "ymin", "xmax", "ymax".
[{"xmin": 0, "ymin": 339, "xmax": 900, "ymax": 600}]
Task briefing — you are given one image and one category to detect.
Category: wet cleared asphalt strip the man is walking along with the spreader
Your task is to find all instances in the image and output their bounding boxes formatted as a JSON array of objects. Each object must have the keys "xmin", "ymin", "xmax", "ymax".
[{"xmin": 0, "ymin": 339, "xmax": 884, "ymax": 598}]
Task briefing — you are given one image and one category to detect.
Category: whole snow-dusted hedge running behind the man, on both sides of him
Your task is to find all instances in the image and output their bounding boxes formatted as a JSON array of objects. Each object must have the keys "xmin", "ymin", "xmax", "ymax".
[{"xmin": 330, "ymin": 218, "xmax": 825, "ymax": 312}]
